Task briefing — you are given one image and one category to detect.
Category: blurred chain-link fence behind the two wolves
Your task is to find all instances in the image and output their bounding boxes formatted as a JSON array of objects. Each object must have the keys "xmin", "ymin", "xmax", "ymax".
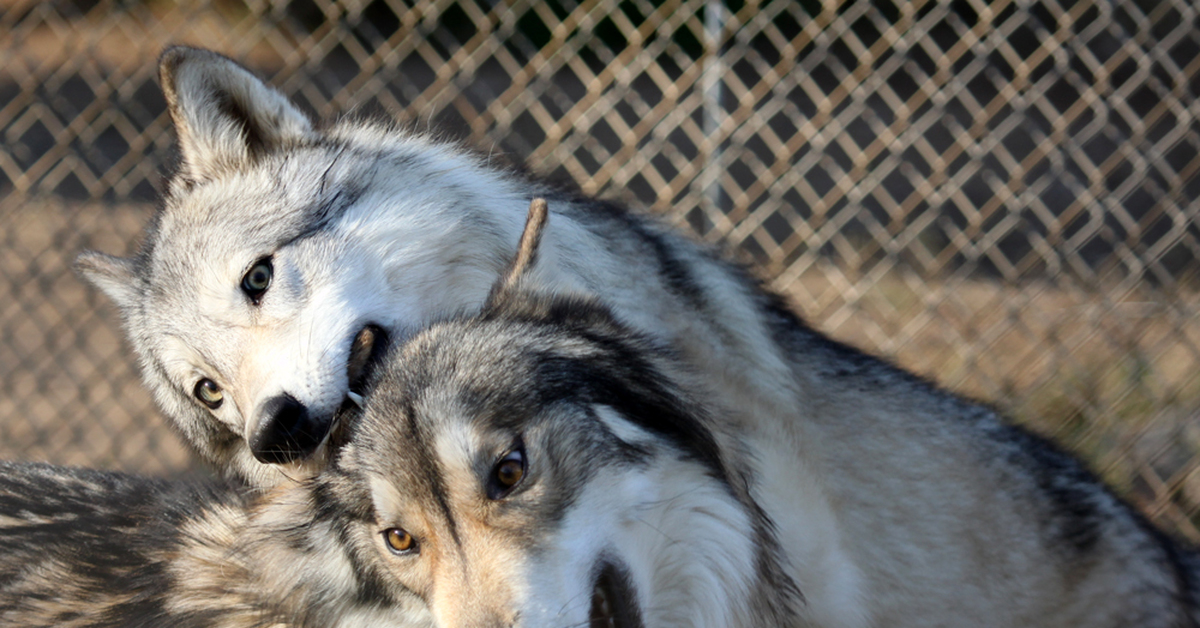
[{"xmin": 0, "ymin": 0, "xmax": 1200, "ymax": 539}]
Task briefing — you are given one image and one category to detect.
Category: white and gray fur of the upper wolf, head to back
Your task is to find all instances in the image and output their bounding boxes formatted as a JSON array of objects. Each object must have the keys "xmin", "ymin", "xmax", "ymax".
[{"xmin": 79, "ymin": 49, "xmax": 1196, "ymax": 627}]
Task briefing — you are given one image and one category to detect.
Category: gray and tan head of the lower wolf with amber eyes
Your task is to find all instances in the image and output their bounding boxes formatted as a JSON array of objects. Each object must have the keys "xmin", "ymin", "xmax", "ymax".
[{"xmin": 326, "ymin": 285, "xmax": 782, "ymax": 628}]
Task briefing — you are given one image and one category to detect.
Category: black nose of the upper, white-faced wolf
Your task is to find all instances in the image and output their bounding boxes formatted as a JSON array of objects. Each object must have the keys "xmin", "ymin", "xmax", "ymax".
[{"xmin": 250, "ymin": 394, "xmax": 330, "ymax": 465}]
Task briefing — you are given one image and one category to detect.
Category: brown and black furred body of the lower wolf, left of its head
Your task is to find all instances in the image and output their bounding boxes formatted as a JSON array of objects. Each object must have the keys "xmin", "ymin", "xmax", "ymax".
[{"xmin": 0, "ymin": 462, "xmax": 430, "ymax": 628}]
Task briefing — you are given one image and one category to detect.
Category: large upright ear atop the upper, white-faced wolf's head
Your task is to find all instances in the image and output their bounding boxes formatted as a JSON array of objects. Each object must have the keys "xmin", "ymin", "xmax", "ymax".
[{"xmin": 158, "ymin": 46, "xmax": 313, "ymax": 181}]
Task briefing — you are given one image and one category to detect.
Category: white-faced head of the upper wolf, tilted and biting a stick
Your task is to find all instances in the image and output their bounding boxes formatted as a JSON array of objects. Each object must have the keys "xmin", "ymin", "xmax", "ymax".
[{"xmin": 77, "ymin": 48, "xmax": 529, "ymax": 484}]
